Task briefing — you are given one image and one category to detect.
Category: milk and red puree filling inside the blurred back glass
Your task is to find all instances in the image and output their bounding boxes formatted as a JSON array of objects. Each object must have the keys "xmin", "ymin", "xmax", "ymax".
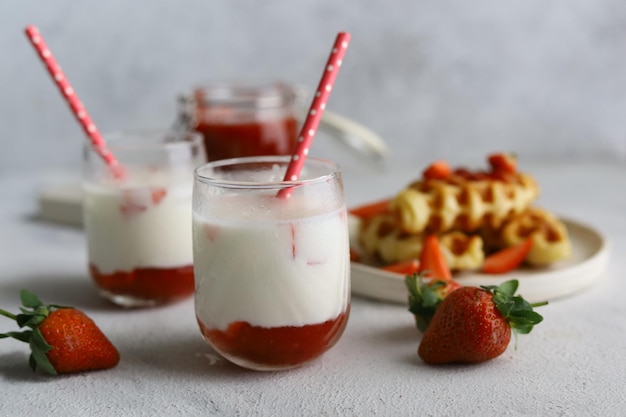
[{"xmin": 84, "ymin": 171, "xmax": 194, "ymax": 306}]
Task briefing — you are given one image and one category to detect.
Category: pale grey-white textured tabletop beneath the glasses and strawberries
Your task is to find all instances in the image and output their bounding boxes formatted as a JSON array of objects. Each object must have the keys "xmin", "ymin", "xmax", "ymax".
[{"xmin": 0, "ymin": 158, "xmax": 626, "ymax": 416}]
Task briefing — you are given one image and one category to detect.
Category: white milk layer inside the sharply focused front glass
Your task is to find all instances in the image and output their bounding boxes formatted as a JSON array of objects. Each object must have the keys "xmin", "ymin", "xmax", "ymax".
[{"xmin": 193, "ymin": 198, "xmax": 350, "ymax": 329}]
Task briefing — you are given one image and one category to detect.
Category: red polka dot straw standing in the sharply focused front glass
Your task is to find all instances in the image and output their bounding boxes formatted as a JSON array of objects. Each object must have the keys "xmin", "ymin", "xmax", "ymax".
[{"xmin": 282, "ymin": 32, "xmax": 350, "ymax": 196}]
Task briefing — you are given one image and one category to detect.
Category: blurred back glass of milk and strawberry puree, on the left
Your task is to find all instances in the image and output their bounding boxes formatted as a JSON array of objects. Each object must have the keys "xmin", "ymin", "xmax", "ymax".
[{"xmin": 83, "ymin": 130, "xmax": 206, "ymax": 307}]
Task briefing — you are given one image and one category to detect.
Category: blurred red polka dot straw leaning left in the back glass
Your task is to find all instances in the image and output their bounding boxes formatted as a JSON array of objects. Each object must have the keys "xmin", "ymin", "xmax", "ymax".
[{"xmin": 25, "ymin": 25, "xmax": 123, "ymax": 178}]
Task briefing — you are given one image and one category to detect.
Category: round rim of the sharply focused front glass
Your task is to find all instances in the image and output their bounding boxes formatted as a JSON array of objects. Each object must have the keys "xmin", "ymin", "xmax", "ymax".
[{"xmin": 194, "ymin": 155, "xmax": 341, "ymax": 190}]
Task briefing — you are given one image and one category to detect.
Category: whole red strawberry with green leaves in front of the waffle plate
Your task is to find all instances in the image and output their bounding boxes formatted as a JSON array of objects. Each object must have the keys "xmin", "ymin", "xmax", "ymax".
[{"xmin": 417, "ymin": 280, "xmax": 547, "ymax": 365}]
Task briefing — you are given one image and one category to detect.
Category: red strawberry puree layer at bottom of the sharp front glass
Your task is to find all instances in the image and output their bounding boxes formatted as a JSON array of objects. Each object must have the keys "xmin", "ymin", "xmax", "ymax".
[{"xmin": 198, "ymin": 309, "xmax": 349, "ymax": 367}]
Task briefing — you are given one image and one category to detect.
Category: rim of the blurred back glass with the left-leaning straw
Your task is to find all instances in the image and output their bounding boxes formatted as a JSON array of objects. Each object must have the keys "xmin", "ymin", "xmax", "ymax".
[{"xmin": 83, "ymin": 128, "xmax": 204, "ymax": 153}]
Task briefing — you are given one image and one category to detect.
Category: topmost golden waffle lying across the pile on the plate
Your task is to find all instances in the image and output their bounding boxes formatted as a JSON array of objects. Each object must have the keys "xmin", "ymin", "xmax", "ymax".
[{"xmin": 390, "ymin": 170, "xmax": 539, "ymax": 234}]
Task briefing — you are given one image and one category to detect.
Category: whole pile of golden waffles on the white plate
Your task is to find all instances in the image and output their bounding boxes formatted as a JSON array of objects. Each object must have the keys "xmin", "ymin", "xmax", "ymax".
[{"xmin": 357, "ymin": 154, "xmax": 570, "ymax": 271}]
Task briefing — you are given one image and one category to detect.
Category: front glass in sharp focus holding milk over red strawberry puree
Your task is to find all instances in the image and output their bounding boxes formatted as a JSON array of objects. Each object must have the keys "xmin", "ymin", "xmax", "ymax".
[{"xmin": 193, "ymin": 156, "xmax": 350, "ymax": 370}]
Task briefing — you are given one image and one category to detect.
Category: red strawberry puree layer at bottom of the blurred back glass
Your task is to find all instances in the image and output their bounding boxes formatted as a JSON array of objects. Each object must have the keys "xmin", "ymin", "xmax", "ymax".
[{"xmin": 89, "ymin": 265, "xmax": 194, "ymax": 303}]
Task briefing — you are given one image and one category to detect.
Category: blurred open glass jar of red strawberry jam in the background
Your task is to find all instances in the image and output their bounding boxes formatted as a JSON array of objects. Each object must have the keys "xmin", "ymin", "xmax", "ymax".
[{"xmin": 179, "ymin": 82, "xmax": 298, "ymax": 161}]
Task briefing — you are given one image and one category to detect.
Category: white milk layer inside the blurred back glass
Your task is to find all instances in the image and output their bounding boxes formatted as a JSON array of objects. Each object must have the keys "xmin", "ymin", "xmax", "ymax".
[{"xmin": 83, "ymin": 172, "xmax": 193, "ymax": 274}]
